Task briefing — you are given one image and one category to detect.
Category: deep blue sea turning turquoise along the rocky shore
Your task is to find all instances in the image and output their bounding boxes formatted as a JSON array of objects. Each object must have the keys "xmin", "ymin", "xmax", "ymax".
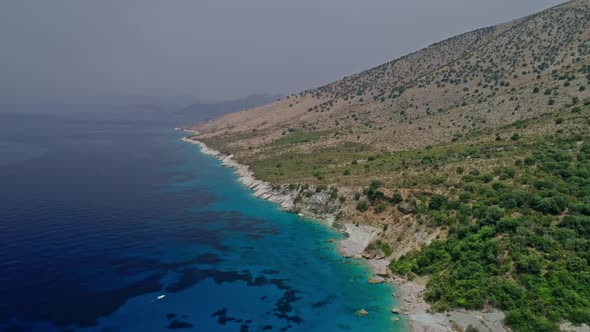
[{"xmin": 0, "ymin": 109, "xmax": 402, "ymax": 331}]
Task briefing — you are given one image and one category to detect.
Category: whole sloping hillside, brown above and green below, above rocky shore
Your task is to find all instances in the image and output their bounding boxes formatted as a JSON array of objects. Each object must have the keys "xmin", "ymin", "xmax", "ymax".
[{"xmin": 190, "ymin": 0, "xmax": 590, "ymax": 331}]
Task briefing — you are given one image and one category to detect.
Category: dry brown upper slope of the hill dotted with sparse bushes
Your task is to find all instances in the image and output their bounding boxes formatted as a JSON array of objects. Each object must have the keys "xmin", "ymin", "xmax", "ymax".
[{"xmin": 193, "ymin": 0, "xmax": 590, "ymax": 161}]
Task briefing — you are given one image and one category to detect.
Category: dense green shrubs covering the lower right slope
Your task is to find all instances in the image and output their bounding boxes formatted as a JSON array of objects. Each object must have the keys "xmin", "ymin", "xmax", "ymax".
[{"xmin": 391, "ymin": 134, "xmax": 590, "ymax": 331}]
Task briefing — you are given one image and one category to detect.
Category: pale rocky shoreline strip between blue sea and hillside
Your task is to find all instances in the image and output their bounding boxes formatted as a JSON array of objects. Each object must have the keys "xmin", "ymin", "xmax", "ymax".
[{"xmin": 177, "ymin": 132, "xmax": 510, "ymax": 332}]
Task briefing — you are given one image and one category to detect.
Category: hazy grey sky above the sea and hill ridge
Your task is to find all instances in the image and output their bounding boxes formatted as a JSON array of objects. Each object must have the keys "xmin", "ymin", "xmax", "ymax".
[{"xmin": 0, "ymin": 0, "xmax": 562, "ymax": 101}]
